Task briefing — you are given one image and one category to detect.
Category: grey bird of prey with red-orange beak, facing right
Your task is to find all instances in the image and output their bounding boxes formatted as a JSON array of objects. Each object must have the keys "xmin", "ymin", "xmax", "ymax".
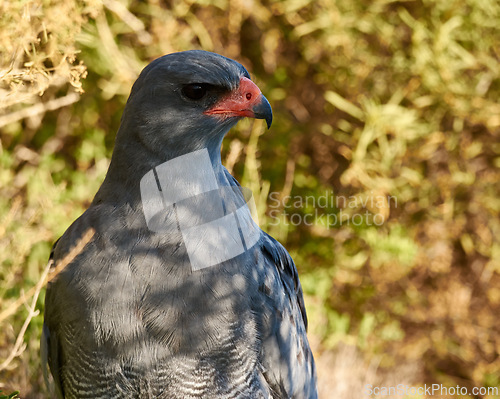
[{"xmin": 41, "ymin": 50, "xmax": 317, "ymax": 399}]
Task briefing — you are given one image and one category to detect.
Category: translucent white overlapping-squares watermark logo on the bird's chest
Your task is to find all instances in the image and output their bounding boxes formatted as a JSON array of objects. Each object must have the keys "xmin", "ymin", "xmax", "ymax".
[{"xmin": 140, "ymin": 149, "xmax": 260, "ymax": 271}]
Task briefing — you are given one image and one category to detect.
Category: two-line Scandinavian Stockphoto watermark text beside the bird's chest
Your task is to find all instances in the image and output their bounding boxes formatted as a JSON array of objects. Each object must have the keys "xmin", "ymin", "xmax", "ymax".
[{"xmin": 268, "ymin": 191, "xmax": 398, "ymax": 228}]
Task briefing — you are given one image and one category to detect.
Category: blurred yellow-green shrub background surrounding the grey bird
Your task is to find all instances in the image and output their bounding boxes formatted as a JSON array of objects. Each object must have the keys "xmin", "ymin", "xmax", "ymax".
[{"xmin": 0, "ymin": 0, "xmax": 500, "ymax": 399}]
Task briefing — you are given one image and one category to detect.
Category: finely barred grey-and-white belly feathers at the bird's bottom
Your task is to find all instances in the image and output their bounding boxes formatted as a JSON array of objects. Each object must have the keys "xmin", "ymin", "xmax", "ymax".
[{"xmin": 55, "ymin": 328, "xmax": 271, "ymax": 399}]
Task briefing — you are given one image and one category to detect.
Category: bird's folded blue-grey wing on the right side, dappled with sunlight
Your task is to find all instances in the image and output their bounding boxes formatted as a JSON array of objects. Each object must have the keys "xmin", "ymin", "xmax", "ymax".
[{"xmin": 261, "ymin": 233, "xmax": 317, "ymax": 399}]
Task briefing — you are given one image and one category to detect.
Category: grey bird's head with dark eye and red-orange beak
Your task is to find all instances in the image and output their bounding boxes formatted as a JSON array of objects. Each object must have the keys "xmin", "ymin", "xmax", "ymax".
[{"xmin": 115, "ymin": 50, "xmax": 272, "ymax": 167}]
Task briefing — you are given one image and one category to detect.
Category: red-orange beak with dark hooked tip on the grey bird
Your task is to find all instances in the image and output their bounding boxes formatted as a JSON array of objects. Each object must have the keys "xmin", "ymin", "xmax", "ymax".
[{"xmin": 204, "ymin": 76, "xmax": 273, "ymax": 129}]
